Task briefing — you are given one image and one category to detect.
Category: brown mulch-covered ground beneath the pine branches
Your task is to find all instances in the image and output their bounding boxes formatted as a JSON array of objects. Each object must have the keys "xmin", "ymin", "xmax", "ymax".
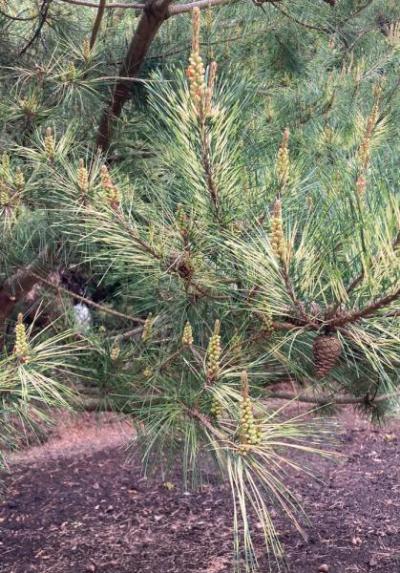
[{"xmin": 0, "ymin": 411, "xmax": 400, "ymax": 573}]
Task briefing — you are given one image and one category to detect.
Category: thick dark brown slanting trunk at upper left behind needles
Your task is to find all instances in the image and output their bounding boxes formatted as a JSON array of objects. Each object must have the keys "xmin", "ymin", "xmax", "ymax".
[{"xmin": 97, "ymin": 0, "xmax": 172, "ymax": 152}]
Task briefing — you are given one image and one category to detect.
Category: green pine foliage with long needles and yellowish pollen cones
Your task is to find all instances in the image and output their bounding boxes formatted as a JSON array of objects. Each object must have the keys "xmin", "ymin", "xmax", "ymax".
[{"xmin": 0, "ymin": 0, "xmax": 400, "ymax": 568}]
